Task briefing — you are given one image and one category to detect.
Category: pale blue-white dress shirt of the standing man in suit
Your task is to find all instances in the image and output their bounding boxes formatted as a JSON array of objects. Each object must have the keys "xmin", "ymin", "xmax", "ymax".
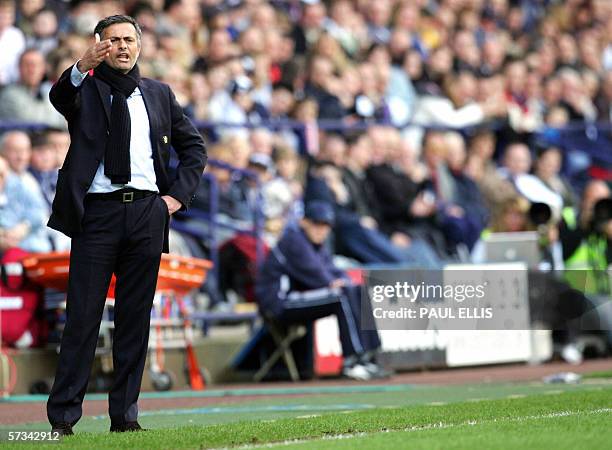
[{"xmin": 70, "ymin": 64, "xmax": 159, "ymax": 194}]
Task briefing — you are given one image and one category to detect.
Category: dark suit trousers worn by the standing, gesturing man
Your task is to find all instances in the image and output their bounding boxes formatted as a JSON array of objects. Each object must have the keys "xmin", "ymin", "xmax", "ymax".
[{"xmin": 47, "ymin": 195, "xmax": 169, "ymax": 425}]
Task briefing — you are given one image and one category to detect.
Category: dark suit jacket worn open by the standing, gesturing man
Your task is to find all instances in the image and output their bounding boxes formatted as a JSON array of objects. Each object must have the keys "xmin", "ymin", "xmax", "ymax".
[{"xmin": 48, "ymin": 67, "xmax": 207, "ymax": 253}]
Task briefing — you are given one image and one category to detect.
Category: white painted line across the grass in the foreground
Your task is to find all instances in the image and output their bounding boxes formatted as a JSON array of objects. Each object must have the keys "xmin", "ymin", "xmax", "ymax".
[{"xmin": 213, "ymin": 408, "xmax": 612, "ymax": 450}]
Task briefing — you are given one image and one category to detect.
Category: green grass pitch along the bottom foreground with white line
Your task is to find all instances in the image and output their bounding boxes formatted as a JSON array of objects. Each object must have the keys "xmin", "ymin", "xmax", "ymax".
[{"xmin": 0, "ymin": 378, "xmax": 612, "ymax": 450}]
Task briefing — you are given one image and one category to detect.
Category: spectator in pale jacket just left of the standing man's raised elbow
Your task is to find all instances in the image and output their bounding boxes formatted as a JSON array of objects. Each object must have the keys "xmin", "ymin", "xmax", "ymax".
[{"xmin": 0, "ymin": 49, "xmax": 66, "ymax": 129}]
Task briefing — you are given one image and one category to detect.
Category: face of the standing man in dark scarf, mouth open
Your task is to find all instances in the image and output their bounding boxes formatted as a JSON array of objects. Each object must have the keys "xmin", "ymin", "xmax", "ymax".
[{"xmin": 100, "ymin": 23, "xmax": 140, "ymax": 73}]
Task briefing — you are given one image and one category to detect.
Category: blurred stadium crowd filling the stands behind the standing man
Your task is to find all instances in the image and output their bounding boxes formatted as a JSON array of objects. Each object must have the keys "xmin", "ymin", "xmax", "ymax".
[{"xmin": 0, "ymin": 0, "xmax": 612, "ymax": 354}]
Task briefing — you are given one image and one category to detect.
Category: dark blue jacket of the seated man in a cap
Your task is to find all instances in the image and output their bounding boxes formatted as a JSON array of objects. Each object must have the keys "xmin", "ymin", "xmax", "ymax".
[{"xmin": 255, "ymin": 225, "xmax": 346, "ymax": 315}]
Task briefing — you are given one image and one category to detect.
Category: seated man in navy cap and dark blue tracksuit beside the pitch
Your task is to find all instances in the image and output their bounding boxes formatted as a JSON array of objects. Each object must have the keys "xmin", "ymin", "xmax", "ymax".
[{"xmin": 255, "ymin": 200, "xmax": 387, "ymax": 380}]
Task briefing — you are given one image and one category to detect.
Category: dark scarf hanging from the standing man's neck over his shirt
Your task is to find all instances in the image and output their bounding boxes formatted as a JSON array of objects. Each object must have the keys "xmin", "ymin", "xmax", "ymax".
[{"xmin": 94, "ymin": 62, "xmax": 140, "ymax": 184}]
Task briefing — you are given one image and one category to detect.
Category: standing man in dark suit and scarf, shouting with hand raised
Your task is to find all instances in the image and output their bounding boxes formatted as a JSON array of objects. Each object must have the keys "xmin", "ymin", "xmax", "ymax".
[{"xmin": 47, "ymin": 16, "xmax": 206, "ymax": 435}]
